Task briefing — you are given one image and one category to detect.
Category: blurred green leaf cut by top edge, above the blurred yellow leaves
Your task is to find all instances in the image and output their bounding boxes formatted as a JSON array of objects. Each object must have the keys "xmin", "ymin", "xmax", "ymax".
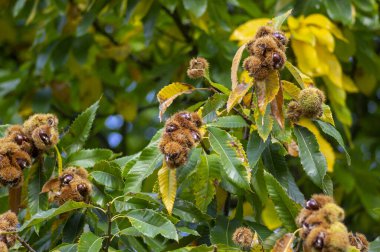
[{"xmin": 324, "ymin": 0, "xmax": 354, "ymax": 25}]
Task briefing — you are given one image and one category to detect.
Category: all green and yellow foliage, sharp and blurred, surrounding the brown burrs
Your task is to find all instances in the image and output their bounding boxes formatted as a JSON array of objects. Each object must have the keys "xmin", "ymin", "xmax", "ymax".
[{"xmin": 0, "ymin": 0, "xmax": 380, "ymax": 251}]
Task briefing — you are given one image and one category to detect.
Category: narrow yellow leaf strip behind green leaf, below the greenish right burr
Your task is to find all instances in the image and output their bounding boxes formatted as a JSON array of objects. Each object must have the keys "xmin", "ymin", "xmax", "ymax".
[{"xmin": 297, "ymin": 118, "xmax": 335, "ymax": 172}]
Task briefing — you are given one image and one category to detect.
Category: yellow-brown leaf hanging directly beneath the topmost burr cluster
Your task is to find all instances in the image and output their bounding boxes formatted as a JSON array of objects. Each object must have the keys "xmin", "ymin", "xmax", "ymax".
[{"xmin": 255, "ymin": 71, "xmax": 280, "ymax": 115}]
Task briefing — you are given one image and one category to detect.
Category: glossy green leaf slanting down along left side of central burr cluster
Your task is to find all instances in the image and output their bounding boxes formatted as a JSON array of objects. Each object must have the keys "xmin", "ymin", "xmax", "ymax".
[{"xmin": 124, "ymin": 130, "xmax": 163, "ymax": 192}]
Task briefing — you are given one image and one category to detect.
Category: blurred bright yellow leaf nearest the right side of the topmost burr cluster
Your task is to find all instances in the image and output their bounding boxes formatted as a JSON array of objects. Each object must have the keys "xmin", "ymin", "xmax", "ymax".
[{"xmin": 291, "ymin": 39, "xmax": 326, "ymax": 76}]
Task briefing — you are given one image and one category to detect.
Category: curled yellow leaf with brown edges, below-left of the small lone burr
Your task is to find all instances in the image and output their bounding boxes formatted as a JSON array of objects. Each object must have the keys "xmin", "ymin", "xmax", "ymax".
[{"xmin": 157, "ymin": 82, "xmax": 196, "ymax": 120}]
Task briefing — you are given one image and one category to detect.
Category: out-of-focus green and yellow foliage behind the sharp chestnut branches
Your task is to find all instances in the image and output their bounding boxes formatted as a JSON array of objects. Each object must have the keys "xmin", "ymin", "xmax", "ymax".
[{"xmin": 0, "ymin": 0, "xmax": 380, "ymax": 236}]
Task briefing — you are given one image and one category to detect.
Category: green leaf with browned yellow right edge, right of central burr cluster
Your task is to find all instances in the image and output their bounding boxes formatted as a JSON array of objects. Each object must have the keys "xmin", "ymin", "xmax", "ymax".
[{"xmin": 208, "ymin": 127, "xmax": 250, "ymax": 189}]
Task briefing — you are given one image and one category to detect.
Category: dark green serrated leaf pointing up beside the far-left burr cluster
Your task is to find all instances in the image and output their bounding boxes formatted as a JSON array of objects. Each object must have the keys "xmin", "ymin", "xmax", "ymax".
[{"xmin": 60, "ymin": 100, "xmax": 99, "ymax": 155}]
